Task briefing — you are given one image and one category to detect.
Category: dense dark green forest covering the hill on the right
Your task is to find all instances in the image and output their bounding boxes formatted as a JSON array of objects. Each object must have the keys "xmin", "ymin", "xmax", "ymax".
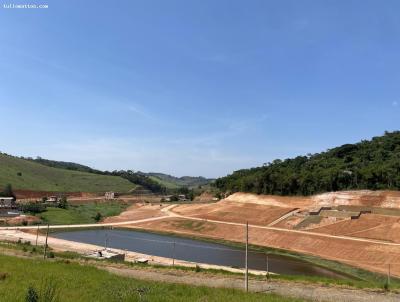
[{"xmin": 215, "ymin": 131, "xmax": 400, "ymax": 195}]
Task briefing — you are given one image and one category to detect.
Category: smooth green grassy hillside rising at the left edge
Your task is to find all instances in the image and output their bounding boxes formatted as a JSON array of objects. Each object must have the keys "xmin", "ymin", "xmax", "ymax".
[{"xmin": 0, "ymin": 154, "xmax": 135, "ymax": 192}]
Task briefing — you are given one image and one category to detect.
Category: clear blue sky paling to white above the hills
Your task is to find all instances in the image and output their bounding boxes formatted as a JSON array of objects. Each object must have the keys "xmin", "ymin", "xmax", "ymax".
[{"xmin": 0, "ymin": 0, "xmax": 400, "ymax": 177}]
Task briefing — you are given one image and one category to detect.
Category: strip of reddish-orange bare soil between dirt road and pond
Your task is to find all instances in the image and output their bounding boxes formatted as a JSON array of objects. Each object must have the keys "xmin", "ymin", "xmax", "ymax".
[{"xmin": 132, "ymin": 218, "xmax": 400, "ymax": 276}]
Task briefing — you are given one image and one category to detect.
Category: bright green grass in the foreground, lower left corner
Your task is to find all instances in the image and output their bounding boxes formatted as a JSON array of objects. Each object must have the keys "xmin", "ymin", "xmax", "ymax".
[{"xmin": 0, "ymin": 255, "xmax": 300, "ymax": 302}]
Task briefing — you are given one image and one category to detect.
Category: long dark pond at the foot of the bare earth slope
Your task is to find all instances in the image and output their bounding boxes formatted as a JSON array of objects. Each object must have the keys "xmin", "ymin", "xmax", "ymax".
[{"xmin": 51, "ymin": 229, "xmax": 344, "ymax": 279}]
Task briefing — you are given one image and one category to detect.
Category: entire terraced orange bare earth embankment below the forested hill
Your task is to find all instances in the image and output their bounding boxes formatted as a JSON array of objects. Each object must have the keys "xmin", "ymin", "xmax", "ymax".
[{"xmin": 119, "ymin": 191, "xmax": 400, "ymax": 276}]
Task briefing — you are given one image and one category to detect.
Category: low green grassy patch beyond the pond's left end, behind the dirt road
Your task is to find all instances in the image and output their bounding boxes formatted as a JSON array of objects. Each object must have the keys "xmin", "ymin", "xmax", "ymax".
[{"xmin": 38, "ymin": 202, "xmax": 127, "ymax": 224}]
